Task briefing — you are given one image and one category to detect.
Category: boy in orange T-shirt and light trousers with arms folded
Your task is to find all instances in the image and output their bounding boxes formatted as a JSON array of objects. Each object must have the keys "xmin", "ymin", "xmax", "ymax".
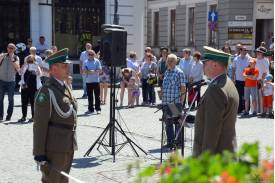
[{"xmin": 242, "ymin": 58, "xmax": 259, "ymax": 117}]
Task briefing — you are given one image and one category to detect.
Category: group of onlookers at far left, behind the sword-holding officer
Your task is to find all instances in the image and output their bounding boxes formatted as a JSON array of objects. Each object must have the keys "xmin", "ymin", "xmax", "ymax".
[{"xmin": 0, "ymin": 36, "xmax": 64, "ymax": 122}]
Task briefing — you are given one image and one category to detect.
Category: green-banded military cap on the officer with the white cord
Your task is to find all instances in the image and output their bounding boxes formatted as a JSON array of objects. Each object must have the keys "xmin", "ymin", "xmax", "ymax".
[{"xmin": 45, "ymin": 48, "xmax": 71, "ymax": 65}]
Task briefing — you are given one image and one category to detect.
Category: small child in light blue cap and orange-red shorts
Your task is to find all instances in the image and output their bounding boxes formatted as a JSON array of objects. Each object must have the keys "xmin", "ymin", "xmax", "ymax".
[{"xmin": 261, "ymin": 74, "xmax": 274, "ymax": 118}]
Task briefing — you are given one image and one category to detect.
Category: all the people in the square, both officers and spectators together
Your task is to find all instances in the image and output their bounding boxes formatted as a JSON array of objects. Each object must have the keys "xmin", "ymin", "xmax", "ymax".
[{"xmin": 0, "ymin": 36, "xmax": 274, "ymax": 181}]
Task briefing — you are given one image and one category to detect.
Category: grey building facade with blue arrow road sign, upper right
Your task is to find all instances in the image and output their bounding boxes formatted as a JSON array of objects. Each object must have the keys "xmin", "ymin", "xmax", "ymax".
[{"xmin": 145, "ymin": 0, "xmax": 274, "ymax": 53}]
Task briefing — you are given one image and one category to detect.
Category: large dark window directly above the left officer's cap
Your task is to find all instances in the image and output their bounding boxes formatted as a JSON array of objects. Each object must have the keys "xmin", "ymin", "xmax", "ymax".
[{"xmin": 54, "ymin": 0, "xmax": 105, "ymax": 58}]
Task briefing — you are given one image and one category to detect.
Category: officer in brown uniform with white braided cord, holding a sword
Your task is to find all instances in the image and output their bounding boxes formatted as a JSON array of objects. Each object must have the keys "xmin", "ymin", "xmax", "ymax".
[{"xmin": 33, "ymin": 49, "xmax": 77, "ymax": 183}]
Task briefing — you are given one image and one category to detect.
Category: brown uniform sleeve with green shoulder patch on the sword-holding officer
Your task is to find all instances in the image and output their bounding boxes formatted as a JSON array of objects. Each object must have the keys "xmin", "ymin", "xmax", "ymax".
[{"xmin": 33, "ymin": 87, "xmax": 51, "ymax": 155}]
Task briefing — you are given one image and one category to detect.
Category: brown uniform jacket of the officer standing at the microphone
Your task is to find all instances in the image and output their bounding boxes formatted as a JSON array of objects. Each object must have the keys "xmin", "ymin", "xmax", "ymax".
[{"xmin": 193, "ymin": 74, "xmax": 239, "ymax": 156}]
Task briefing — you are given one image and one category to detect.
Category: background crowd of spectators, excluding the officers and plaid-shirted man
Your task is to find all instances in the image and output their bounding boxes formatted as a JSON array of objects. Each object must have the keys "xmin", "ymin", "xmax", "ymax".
[{"xmin": 0, "ymin": 36, "xmax": 274, "ymax": 122}]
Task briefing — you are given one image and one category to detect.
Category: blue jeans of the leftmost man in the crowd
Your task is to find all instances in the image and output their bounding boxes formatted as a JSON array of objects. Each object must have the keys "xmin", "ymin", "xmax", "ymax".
[{"xmin": 0, "ymin": 80, "xmax": 15, "ymax": 118}]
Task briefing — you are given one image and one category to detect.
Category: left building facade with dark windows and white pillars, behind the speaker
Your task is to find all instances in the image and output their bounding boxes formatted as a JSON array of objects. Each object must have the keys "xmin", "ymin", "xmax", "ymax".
[{"xmin": 0, "ymin": 0, "xmax": 145, "ymax": 59}]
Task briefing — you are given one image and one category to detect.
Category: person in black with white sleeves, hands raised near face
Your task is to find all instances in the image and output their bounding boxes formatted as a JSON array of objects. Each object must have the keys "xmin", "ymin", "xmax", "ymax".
[{"xmin": 18, "ymin": 55, "xmax": 42, "ymax": 122}]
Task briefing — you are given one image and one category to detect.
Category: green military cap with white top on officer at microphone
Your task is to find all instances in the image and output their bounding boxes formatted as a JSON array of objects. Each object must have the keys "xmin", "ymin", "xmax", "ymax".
[{"xmin": 203, "ymin": 46, "xmax": 231, "ymax": 65}]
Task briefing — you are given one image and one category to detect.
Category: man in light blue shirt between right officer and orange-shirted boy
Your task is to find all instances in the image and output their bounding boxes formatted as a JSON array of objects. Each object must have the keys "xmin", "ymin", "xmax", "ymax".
[{"xmin": 232, "ymin": 46, "xmax": 251, "ymax": 114}]
